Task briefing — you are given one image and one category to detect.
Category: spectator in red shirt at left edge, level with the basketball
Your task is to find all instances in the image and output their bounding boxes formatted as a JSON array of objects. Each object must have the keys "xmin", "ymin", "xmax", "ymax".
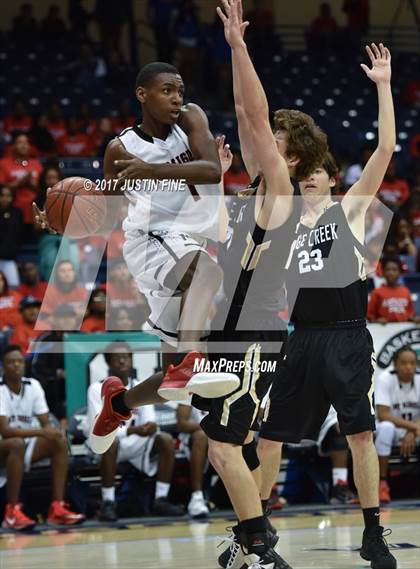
[{"xmin": 0, "ymin": 134, "xmax": 42, "ymax": 232}]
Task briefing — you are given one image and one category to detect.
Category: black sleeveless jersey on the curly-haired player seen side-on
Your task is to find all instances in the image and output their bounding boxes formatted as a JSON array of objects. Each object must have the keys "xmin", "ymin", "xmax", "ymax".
[{"xmin": 219, "ymin": 177, "xmax": 300, "ymax": 330}]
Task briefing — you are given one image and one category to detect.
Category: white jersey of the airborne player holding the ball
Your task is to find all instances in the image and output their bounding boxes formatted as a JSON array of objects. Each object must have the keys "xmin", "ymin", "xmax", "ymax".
[{"xmin": 119, "ymin": 125, "xmax": 220, "ymax": 240}]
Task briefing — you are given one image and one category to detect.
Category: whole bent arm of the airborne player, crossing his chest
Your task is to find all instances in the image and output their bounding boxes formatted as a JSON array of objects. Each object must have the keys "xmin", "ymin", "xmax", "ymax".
[{"xmin": 115, "ymin": 103, "xmax": 221, "ymax": 184}]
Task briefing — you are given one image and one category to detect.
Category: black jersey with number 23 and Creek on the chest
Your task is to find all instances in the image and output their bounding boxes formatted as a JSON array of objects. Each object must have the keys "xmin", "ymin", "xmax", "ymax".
[{"xmin": 286, "ymin": 203, "xmax": 367, "ymax": 325}]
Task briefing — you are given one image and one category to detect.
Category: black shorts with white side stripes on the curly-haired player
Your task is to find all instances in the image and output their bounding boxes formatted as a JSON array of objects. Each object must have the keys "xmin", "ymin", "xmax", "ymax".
[{"xmin": 199, "ymin": 324, "xmax": 287, "ymax": 445}]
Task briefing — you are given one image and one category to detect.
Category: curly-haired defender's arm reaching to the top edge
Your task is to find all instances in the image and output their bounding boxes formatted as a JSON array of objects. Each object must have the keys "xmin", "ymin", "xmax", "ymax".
[{"xmin": 217, "ymin": 0, "xmax": 293, "ymax": 195}]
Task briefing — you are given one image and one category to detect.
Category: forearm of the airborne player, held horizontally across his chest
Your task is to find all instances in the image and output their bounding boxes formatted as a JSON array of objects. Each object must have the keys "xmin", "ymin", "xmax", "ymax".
[{"xmin": 146, "ymin": 160, "xmax": 222, "ymax": 185}]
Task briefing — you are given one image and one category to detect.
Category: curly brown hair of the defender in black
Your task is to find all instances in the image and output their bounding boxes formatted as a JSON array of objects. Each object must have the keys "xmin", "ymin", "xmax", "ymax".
[{"xmin": 273, "ymin": 109, "xmax": 328, "ymax": 180}]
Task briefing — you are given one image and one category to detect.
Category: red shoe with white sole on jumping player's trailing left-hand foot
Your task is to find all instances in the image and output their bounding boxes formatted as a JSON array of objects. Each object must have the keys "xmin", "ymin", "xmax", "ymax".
[{"xmin": 89, "ymin": 376, "xmax": 131, "ymax": 454}]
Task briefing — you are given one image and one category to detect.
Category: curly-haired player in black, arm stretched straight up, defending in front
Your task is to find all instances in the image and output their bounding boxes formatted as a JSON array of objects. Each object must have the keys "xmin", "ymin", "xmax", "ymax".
[{"xmin": 204, "ymin": 1, "xmax": 327, "ymax": 569}]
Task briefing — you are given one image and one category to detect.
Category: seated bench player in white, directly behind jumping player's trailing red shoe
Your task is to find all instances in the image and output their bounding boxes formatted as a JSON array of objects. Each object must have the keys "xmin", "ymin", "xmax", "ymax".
[{"xmin": 86, "ymin": 342, "xmax": 183, "ymax": 521}]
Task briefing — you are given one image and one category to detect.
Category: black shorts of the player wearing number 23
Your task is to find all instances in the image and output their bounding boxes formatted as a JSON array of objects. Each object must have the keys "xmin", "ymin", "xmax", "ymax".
[{"xmin": 260, "ymin": 322, "xmax": 376, "ymax": 443}]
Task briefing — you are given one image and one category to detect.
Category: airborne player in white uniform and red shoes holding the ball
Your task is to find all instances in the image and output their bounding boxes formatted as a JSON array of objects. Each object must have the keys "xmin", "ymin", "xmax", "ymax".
[{"xmin": 34, "ymin": 62, "xmax": 238, "ymax": 453}]
